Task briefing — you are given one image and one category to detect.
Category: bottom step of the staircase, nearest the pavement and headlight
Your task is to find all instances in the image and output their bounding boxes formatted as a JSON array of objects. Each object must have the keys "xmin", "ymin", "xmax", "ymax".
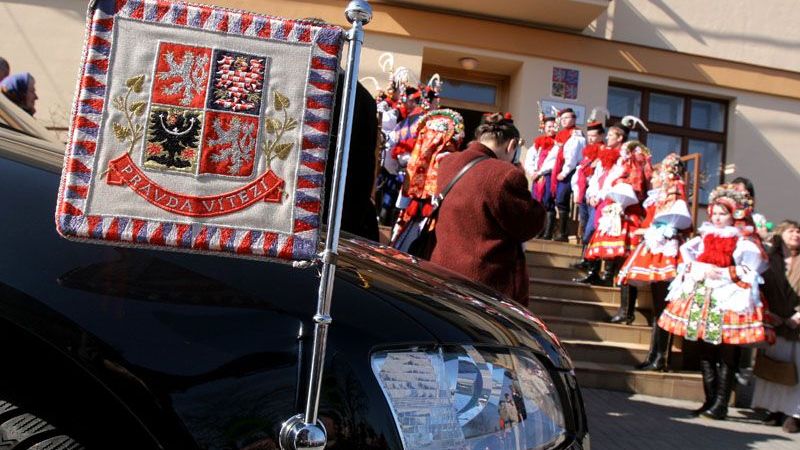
[{"xmin": 574, "ymin": 361, "xmax": 704, "ymax": 402}]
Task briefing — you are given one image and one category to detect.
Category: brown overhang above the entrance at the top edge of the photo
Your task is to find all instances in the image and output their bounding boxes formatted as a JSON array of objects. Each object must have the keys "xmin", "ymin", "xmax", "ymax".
[{"xmin": 372, "ymin": 0, "xmax": 611, "ymax": 32}]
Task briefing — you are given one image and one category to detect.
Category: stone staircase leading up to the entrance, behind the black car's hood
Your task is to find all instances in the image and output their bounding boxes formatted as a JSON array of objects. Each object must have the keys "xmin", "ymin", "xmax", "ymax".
[{"xmin": 526, "ymin": 240, "xmax": 703, "ymax": 401}]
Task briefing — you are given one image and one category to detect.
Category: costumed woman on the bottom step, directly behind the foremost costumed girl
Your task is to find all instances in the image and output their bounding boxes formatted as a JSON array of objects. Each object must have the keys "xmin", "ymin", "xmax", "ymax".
[{"xmin": 611, "ymin": 153, "xmax": 692, "ymax": 370}]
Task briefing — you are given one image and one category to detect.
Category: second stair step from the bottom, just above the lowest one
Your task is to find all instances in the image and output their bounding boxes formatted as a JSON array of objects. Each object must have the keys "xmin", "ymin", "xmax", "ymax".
[{"xmin": 539, "ymin": 316, "xmax": 653, "ymax": 345}]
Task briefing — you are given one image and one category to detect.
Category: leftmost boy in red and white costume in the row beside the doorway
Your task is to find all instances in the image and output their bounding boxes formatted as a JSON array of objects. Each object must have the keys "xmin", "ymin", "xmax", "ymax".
[{"xmin": 522, "ymin": 111, "xmax": 556, "ymax": 216}]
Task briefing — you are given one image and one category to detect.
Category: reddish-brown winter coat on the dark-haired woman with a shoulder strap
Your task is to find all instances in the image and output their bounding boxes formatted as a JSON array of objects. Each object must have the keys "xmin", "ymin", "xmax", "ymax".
[{"xmin": 431, "ymin": 142, "xmax": 545, "ymax": 305}]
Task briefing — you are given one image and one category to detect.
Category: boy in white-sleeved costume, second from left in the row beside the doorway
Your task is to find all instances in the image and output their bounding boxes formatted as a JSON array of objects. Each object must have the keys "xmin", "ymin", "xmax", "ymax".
[{"xmin": 544, "ymin": 108, "xmax": 586, "ymax": 242}]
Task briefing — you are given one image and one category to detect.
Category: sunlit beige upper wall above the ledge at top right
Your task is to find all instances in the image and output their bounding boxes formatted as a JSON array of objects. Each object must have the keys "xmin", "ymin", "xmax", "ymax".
[{"xmin": 584, "ymin": 0, "xmax": 800, "ymax": 72}]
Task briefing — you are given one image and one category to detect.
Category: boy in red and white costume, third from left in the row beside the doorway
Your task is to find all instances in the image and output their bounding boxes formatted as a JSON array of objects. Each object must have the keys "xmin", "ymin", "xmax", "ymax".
[{"xmin": 572, "ymin": 108, "xmax": 606, "ymax": 270}]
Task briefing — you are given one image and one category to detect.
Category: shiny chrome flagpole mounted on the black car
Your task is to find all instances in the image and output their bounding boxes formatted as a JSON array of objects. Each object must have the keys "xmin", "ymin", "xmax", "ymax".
[{"xmin": 280, "ymin": 0, "xmax": 372, "ymax": 450}]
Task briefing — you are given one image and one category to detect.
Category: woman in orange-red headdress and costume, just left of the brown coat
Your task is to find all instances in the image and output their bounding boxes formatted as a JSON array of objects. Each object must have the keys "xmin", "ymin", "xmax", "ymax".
[{"xmin": 392, "ymin": 109, "xmax": 464, "ymax": 251}]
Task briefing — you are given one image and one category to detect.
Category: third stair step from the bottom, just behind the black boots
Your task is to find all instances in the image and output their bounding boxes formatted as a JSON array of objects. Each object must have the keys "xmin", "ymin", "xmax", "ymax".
[{"xmin": 530, "ymin": 277, "xmax": 653, "ymax": 310}]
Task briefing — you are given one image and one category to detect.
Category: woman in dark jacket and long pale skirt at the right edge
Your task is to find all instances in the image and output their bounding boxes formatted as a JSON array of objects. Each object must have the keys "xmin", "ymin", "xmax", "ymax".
[{"xmin": 753, "ymin": 220, "xmax": 800, "ymax": 433}]
